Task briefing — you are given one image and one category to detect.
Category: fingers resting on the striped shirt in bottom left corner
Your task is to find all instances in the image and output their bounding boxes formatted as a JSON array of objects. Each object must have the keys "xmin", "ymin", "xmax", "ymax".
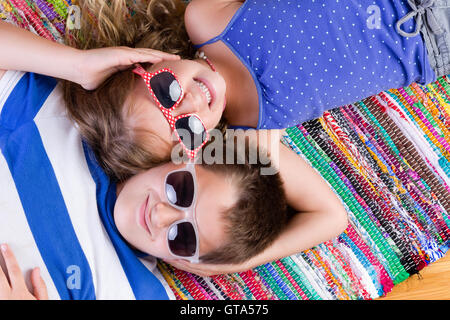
[{"xmin": 0, "ymin": 244, "xmax": 48, "ymax": 300}]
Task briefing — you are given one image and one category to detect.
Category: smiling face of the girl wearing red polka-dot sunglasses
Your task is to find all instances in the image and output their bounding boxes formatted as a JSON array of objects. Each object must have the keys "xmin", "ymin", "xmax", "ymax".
[{"xmin": 128, "ymin": 59, "xmax": 226, "ymax": 150}]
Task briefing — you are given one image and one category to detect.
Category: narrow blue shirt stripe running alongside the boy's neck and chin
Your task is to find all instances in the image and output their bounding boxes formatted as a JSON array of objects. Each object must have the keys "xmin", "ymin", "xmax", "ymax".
[{"xmin": 83, "ymin": 143, "xmax": 169, "ymax": 300}]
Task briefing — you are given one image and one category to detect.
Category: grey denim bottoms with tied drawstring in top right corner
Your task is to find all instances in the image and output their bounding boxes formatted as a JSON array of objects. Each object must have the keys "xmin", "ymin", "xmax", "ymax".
[{"xmin": 396, "ymin": 0, "xmax": 450, "ymax": 77}]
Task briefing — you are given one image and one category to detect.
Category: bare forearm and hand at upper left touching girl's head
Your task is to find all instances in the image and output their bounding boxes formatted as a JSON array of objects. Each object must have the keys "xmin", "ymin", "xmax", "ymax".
[{"xmin": 0, "ymin": 20, "xmax": 179, "ymax": 90}]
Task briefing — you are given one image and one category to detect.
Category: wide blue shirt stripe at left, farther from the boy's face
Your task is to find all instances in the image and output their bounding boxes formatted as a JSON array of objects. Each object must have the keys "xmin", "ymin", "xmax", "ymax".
[{"xmin": 0, "ymin": 73, "xmax": 95, "ymax": 300}]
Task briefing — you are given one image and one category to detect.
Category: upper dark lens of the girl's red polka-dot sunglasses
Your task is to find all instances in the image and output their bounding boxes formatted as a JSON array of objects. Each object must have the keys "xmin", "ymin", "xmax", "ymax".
[{"xmin": 150, "ymin": 72, "xmax": 181, "ymax": 109}]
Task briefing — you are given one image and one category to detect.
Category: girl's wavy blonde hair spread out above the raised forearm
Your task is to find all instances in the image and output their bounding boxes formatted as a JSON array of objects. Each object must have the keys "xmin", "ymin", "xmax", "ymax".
[{"xmin": 66, "ymin": 0, "xmax": 195, "ymax": 59}]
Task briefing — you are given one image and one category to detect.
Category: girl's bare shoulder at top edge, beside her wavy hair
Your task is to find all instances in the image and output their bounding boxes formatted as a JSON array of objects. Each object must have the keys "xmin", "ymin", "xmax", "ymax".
[{"xmin": 184, "ymin": 0, "xmax": 244, "ymax": 44}]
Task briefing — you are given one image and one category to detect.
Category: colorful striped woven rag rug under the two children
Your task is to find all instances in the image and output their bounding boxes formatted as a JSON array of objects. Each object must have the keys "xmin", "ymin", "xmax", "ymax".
[{"xmin": 0, "ymin": 0, "xmax": 450, "ymax": 300}]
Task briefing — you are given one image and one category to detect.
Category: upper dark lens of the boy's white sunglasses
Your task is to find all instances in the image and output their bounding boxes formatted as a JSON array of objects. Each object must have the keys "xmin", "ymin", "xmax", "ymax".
[{"xmin": 166, "ymin": 171, "xmax": 195, "ymax": 208}]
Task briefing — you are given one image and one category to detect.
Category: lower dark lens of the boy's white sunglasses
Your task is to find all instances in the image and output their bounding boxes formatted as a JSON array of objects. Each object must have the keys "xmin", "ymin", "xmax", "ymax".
[{"xmin": 167, "ymin": 222, "xmax": 197, "ymax": 257}]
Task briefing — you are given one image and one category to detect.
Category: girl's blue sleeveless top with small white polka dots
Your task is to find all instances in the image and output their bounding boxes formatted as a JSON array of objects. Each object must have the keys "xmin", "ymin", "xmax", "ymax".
[{"xmin": 197, "ymin": 0, "xmax": 435, "ymax": 129}]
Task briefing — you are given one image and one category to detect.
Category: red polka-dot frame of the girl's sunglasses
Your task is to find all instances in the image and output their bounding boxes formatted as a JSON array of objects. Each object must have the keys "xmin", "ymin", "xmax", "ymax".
[{"xmin": 133, "ymin": 64, "xmax": 209, "ymax": 159}]
